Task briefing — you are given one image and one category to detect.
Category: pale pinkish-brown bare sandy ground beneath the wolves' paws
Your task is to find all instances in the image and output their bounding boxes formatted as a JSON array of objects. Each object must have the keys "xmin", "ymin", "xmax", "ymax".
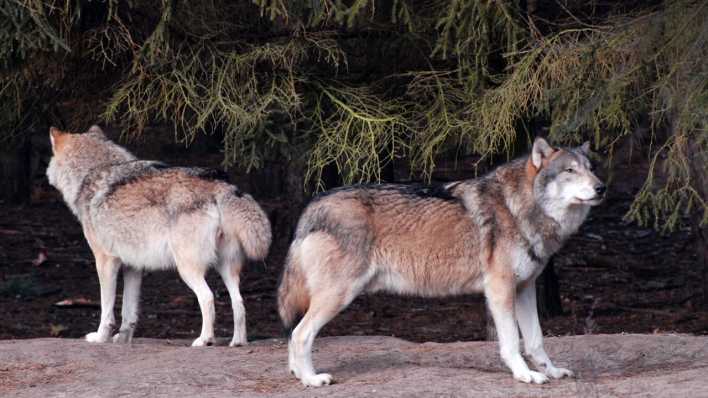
[{"xmin": 0, "ymin": 334, "xmax": 708, "ymax": 398}]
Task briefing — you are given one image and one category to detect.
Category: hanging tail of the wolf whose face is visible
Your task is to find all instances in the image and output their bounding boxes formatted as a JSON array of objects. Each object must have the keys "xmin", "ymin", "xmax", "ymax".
[{"xmin": 278, "ymin": 246, "xmax": 310, "ymax": 331}]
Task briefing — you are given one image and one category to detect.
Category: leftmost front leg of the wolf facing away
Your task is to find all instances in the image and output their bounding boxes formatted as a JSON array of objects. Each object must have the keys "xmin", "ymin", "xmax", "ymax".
[{"xmin": 86, "ymin": 256, "xmax": 120, "ymax": 343}]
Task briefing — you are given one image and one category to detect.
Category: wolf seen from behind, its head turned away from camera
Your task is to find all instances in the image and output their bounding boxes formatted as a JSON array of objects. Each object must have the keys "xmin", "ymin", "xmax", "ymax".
[{"xmin": 47, "ymin": 126, "xmax": 271, "ymax": 346}]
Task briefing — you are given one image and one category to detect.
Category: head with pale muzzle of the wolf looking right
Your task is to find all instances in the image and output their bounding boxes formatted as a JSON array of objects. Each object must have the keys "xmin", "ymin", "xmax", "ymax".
[{"xmin": 530, "ymin": 138, "xmax": 607, "ymax": 214}]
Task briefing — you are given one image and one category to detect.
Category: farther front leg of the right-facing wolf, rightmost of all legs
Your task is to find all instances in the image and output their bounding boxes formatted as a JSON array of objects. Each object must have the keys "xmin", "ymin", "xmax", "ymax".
[{"xmin": 516, "ymin": 281, "xmax": 573, "ymax": 379}]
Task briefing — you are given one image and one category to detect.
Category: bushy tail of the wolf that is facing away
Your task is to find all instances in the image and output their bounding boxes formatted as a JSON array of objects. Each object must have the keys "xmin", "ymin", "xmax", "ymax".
[{"xmin": 217, "ymin": 187, "xmax": 272, "ymax": 260}]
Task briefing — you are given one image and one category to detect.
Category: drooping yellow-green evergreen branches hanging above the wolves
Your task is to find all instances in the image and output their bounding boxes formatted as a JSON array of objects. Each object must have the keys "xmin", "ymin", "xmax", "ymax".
[{"xmin": 0, "ymin": 0, "xmax": 708, "ymax": 229}]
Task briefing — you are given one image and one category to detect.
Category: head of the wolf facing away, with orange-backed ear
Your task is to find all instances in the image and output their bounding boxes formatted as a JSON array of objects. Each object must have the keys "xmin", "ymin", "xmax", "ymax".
[{"xmin": 47, "ymin": 126, "xmax": 135, "ymax": 214}]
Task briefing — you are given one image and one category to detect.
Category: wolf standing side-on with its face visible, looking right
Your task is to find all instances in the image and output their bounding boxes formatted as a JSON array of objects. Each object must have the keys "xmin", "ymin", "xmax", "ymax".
[{"xmin": 278, "ymin": 138, "xmax": 605, "ymax": 386}]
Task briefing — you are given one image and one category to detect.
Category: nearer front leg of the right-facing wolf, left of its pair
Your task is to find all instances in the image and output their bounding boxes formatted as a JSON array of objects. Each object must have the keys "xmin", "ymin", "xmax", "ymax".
[{"xmin": 484, "ymin": 276, "xmax": 548, "ymax": 384}]
